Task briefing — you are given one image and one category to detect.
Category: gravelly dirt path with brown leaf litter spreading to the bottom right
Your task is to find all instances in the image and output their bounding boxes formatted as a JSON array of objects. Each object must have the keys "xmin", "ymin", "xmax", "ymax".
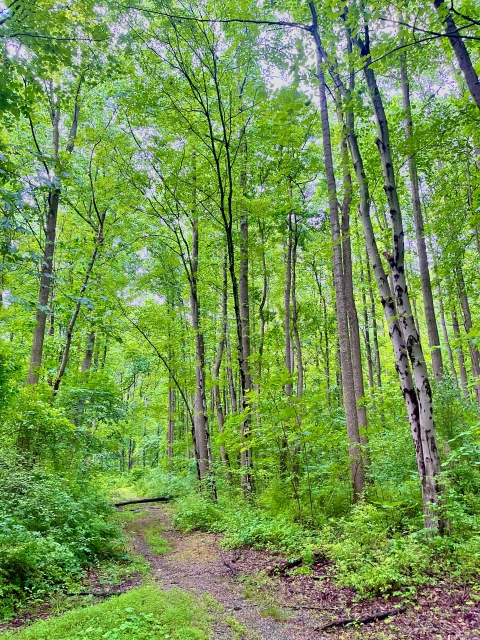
[{"xmin": 127, "ymin": 506, "xmax": 480, "ymax": 640}]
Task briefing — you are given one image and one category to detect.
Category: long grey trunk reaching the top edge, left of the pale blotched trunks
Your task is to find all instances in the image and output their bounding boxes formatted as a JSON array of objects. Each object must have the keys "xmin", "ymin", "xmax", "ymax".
[{"xmin": 309, "ymin": 2, "xmax": 365, "ymax": 500}]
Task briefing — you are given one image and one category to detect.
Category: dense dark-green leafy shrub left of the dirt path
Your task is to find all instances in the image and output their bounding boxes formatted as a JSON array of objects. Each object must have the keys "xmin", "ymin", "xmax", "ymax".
[{"xmin": 0, "ymin": 465, "xmax": 121, "ymax": 617}]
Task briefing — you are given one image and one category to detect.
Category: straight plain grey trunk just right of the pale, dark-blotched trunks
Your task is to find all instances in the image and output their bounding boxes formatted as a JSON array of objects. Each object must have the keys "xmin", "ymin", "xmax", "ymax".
[{"xmin": 400, "ymin": 55, "xmax": 443, "ymax": 382}]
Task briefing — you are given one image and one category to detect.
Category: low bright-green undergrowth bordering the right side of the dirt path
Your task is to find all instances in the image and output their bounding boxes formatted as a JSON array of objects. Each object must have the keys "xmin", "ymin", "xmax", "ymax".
[{"xmin": 163, "ymin": 478, "xmax": 480, "ymax": 598}]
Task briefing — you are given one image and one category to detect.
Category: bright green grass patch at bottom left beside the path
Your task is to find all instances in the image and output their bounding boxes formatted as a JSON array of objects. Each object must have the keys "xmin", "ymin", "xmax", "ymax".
[{"xmin": 0, "ymin": 586, "xmax": 209, "ymax": 640}]
